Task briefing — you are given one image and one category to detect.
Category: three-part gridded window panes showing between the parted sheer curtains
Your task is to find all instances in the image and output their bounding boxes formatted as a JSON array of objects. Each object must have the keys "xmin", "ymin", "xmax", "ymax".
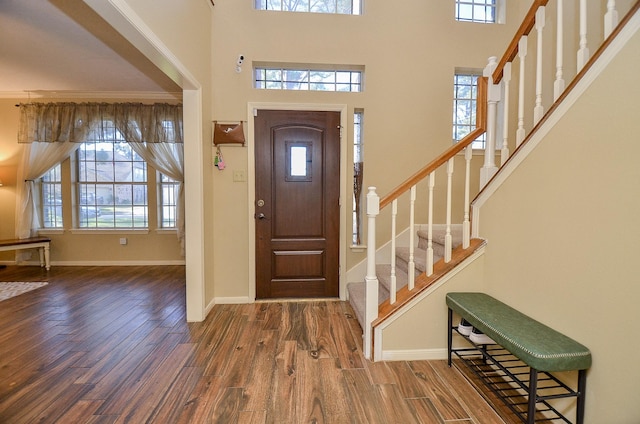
[{"xmin": 40, "ymin": 121, "xmax": 180, "ymax": 229}]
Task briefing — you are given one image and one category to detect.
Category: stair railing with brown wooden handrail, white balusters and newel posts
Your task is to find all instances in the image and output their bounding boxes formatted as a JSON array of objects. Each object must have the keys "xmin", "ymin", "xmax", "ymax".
[{"xmin": 364, "ymin": 0, "xmax": 640, "ymax": 358}]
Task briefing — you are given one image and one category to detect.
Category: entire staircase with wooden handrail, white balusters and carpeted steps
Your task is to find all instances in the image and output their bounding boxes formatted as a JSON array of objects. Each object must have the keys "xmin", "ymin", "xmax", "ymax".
[{"xmin": 347, "ymin": 0, "xmax": 640, "ymax": 361}]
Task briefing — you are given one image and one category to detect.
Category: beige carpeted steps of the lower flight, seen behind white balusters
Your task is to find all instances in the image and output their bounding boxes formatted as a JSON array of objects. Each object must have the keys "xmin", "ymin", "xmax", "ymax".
[{"xmin": 347, "ymin": 225, "xmax": 462, "ymax": 328}]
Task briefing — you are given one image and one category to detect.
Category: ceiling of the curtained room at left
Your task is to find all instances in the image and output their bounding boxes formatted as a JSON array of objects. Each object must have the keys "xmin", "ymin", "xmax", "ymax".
[{"xmin": 0, "ymin": 0, "xmax": 182, "ymax": 97}]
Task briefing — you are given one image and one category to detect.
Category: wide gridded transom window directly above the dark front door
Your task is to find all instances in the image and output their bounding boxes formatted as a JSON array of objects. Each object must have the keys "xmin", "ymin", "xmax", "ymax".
[{"xmin": 254, "ymin": 67, "xmax": 362, "ymax": 92}]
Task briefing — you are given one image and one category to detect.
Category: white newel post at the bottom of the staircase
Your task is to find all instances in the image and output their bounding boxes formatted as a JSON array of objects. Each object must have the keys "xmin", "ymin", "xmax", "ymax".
[{"xmin": 363, "ymin": 187, "xmax": 380, "ymax": 359}]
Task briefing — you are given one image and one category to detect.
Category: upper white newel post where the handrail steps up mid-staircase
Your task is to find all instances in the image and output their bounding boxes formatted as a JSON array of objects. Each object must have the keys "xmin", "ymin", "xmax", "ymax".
[{"xmin": 480, "ymin": 56, "xmax": 501, "ymax": 189}]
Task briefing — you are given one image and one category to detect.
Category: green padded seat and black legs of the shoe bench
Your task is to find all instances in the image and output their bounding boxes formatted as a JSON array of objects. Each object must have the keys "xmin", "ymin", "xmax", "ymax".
[{"xmin": 446, "ymin": 293, "xmax": 591, "ymax": 424}]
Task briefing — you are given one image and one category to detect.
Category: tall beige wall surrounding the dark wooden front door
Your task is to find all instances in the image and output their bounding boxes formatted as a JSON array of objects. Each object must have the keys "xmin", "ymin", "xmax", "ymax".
[{"xmin": 212, "ymin": 0, "xmax": 527, "ymax": 297}]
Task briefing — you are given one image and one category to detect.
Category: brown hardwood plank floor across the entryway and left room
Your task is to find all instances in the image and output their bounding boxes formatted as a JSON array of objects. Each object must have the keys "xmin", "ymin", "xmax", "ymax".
[{"xmin": 0, "ymin": 266, "xmax": 516, "ymax": 424}]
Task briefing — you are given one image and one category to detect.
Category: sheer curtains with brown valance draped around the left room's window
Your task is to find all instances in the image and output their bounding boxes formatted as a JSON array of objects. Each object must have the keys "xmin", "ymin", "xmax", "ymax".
[{"xmin": 16, "ymin": 103, "xmax": 184, "ymax": 248}]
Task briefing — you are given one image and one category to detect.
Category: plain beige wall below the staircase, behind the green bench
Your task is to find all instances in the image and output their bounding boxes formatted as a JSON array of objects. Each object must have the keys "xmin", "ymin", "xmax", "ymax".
[{"xmin": 480, "ymin": 24, "xmax": 640, "ymax": 423}]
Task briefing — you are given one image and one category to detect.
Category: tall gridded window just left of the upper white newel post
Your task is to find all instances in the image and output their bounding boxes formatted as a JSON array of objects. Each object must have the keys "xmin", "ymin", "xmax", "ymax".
[{"xmin": 453, "ymin": 71, "xmax": 485, "ymax": 149}]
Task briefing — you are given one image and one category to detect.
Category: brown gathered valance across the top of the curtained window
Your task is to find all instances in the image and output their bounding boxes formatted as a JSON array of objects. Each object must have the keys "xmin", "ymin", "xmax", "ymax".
[{"xmin": 18, "ymin": 103, "xmax": 183, "ymax": 143}]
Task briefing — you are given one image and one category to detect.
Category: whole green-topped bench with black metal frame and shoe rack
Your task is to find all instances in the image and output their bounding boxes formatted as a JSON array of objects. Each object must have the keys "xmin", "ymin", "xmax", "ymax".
[{"xmin": 446, "ymin": 293, "xmax": 591, "ymax": 424}]
